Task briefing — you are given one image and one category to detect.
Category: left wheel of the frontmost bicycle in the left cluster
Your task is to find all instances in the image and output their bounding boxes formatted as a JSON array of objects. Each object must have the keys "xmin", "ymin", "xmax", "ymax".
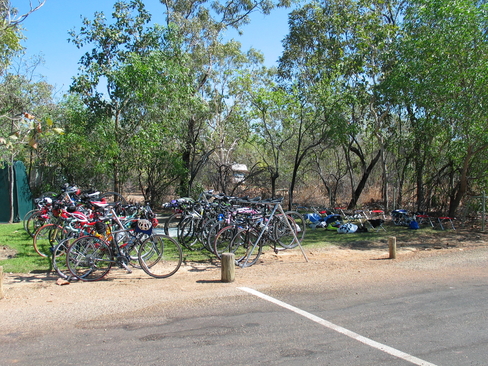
[{"xmin": 66, "ymin": 236, "xmax": 113, "ymax": 281}]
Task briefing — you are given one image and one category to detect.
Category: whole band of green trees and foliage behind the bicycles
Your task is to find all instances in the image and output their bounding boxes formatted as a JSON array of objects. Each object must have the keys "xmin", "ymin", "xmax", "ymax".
[{"xmin": 0, "ymin": 0, "xmax": 488, "ymax": 213}]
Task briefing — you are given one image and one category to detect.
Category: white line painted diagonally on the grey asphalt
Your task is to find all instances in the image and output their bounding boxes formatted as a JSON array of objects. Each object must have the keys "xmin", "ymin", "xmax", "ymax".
[{"xmin": 238, "ymin": 287, "xmax": 436, "ymax": 366}]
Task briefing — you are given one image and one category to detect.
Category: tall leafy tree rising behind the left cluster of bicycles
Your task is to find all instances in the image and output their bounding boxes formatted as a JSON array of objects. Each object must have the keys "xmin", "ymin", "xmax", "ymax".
[{"xmin": 70, "ymin": 0, "xmax": 194, "ymax": 197}]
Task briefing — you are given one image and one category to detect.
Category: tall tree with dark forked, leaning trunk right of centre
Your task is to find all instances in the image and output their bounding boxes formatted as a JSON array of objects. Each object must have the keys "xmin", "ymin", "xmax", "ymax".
[{"xmin": 280, "ymin": 0, "xmax": 401, "ymax": 208}]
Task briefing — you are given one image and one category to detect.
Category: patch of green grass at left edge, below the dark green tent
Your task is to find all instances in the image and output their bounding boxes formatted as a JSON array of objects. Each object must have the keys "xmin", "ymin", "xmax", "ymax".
[{"xmin": 0, "ymin": 223, "xmax": 51, "ymax": 273}]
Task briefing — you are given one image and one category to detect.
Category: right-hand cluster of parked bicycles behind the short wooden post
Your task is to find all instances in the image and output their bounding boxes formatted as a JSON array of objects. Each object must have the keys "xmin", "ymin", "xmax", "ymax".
[{"xmin": 163, "ymin": 191, "xmax": 306, "ymax": 267}]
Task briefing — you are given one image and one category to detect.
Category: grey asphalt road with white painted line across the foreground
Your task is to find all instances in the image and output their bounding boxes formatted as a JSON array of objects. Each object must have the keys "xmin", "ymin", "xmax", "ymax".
[{"xmin": 0, "ymin": 250, "xmax": 488, "ymax": 366}]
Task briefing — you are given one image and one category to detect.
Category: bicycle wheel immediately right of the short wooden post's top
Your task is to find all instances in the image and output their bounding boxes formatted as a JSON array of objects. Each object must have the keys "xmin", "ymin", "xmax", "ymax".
[{"xmin": 229, "ymin": 228, "xmax": 262, "ymax": 267}]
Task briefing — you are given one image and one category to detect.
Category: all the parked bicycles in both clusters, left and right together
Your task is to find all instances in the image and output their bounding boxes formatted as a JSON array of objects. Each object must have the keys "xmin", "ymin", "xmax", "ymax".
[{"xmin": 23, "ymin": 185, "xmax": 306, "ymax": 281}]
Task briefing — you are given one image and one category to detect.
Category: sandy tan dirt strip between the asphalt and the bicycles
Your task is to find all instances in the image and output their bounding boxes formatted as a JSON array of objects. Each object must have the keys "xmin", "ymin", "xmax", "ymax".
[{"xmin": 0, "ymin": 230, "xmax": 488, "ymax": 341}]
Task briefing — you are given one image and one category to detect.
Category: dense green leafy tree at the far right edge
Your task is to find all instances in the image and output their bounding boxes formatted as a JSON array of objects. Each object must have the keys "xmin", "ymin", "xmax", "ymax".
[{"xmin": 388, "ymin": 0, "xmax": 488, "ymax": 215}]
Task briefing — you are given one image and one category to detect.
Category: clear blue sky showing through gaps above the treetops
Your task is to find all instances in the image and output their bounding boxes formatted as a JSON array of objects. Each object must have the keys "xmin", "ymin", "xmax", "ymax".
[{"xmin": 11, "ymin": 0, "xmax": 290, "ymax": 92}]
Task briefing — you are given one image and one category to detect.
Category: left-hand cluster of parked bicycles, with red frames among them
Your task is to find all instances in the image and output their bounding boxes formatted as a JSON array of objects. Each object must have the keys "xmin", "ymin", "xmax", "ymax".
[{"xmin": 24, "ymin": 185, "xmax": 183, "ymax": 281}]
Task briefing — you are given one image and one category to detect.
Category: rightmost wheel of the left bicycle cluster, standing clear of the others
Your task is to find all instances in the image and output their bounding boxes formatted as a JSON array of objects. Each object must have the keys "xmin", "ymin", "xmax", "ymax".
[{"xmin": 139, "ymin": 235, "xmax": 183, "ymax": 278}]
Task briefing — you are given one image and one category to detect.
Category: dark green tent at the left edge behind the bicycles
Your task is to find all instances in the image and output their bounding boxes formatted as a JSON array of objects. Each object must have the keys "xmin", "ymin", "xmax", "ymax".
[{"xmin": 0, "ymin": 161, "xmax": 33, "ymax": 222}]
